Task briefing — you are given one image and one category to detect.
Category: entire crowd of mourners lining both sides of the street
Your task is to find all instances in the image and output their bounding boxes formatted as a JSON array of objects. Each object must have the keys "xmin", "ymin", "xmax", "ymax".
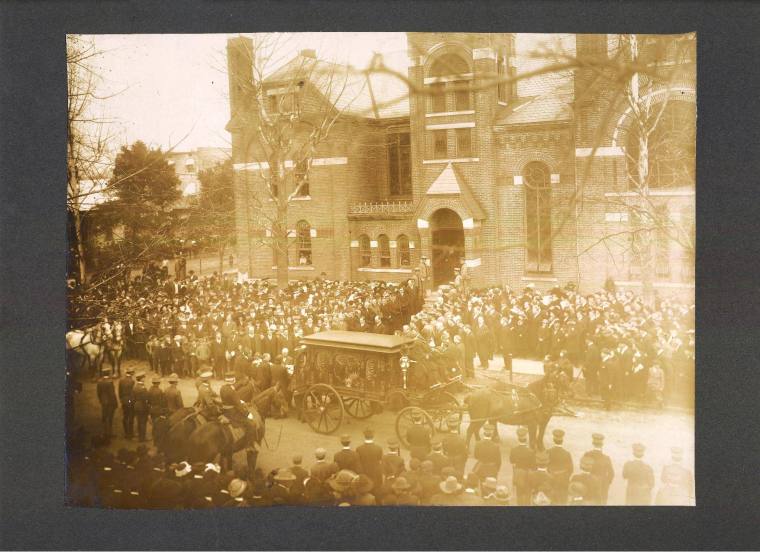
[{"xmin": 69, "ymin": 260, "xmax": 694, "ymax": 508}]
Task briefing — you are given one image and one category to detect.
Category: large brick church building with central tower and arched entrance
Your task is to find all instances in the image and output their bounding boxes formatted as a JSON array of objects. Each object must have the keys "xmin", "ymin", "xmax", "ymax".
[{"xmin": 227, "ymin": 33, "xmax": 696, "ymax": 296}]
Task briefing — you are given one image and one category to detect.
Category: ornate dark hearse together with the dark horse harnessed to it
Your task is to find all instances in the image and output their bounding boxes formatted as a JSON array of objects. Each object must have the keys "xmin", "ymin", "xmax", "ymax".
[{"xmin": 291, "ymin": 331, "xmax": 567, "ymax": 448}]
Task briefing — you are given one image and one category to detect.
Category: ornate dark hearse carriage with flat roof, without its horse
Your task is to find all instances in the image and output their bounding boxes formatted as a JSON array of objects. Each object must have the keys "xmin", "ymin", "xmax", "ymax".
[{"xmin": 291, "ymin": 331, "xmax": 466, "ymax": 445}]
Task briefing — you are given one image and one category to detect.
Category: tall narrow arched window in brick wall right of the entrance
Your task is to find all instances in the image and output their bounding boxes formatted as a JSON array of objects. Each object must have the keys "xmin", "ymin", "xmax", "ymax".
[{"xmin": 523, "ymin": 161, "xmax": 552, "ymax": 272}]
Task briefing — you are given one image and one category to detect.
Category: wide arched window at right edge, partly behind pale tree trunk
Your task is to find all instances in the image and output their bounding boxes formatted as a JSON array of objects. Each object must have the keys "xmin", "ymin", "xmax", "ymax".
[{"xmin": 626, "ymin": 100, "xmax": 697, "ymax": 190}]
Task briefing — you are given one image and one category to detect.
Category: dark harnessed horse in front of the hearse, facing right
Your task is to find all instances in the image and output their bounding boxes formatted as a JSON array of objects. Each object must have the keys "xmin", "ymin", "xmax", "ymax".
[{"xmin": 464, "ymin": 374, "xmax": 569, "ymax": 450}]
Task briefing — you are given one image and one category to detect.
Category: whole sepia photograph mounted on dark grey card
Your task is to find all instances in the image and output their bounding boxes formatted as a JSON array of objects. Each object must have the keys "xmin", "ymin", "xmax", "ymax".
[{"xmin": 65, "ymin": 33, "xmax": 702, "ymax": 510}]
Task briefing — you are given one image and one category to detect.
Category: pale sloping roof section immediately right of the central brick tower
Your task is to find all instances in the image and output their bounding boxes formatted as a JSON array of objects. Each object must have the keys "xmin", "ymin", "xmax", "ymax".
[{"xmin": 494, "ymin": 82, "xmax": 573, "ymax": 126}]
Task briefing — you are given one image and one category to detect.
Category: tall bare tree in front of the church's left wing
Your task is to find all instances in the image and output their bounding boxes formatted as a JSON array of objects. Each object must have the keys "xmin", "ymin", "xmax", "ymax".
[{"xmin": 231, "ymin": 34, "xmax": 350, "ymax": 286}]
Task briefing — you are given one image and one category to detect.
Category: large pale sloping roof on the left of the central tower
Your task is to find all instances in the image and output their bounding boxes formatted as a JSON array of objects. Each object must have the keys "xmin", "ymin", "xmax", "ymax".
[{"xmin": 264, "ymin": 55, "xmax": 409, "ymax": 119}]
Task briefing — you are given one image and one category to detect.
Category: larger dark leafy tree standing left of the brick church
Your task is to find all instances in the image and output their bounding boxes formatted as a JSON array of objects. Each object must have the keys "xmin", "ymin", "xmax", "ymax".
[{"xmin": 109, "ymin": 141, "xmax": 182, "ymax": 262}]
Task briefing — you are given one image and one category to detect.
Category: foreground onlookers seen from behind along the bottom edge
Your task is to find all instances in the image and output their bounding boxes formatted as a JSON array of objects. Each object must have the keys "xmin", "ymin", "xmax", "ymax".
[{"xmin": 68, "ymin": 418, "xmax": 694, "ymax": 509}]
